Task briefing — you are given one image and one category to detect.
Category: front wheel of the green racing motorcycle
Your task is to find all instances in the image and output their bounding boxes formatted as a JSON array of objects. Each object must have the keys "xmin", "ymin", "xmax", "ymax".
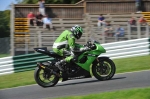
[{"xmin": 92, "ymin": 58, "xmax": 116, "ymax": 81}]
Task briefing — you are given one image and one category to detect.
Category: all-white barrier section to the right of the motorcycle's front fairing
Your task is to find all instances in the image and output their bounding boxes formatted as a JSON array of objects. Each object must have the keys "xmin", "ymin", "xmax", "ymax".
[{"xmin": 100, "ymin": 38, "xmax": 150, "ymax": 59}]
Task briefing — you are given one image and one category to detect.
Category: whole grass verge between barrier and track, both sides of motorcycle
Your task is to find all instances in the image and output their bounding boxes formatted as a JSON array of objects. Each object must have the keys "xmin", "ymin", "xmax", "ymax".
[{"xmin": 0, "ymin": 55, "xmax": 150, "ymax": 89}]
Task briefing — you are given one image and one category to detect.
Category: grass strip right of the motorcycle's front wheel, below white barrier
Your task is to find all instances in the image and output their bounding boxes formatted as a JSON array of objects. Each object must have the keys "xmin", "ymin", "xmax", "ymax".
[{"xmin": 114, "ymin": 55, "xmax": 150, "ymax": 73}]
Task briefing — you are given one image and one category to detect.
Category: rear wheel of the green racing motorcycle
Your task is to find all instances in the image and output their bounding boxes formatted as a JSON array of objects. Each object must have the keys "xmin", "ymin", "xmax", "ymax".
[{"xmin": 34, "ymin": 67, "xmax": 59, "ymax": 87}]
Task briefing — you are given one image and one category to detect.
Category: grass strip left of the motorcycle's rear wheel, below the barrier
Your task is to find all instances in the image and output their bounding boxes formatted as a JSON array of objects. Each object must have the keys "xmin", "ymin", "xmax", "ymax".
[{"xmin": 0, "ymin": 71, "xmax": 35, "ymax": 89}]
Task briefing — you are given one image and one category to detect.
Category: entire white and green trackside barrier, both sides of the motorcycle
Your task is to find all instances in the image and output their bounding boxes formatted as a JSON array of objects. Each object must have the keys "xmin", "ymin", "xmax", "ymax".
[{"xmin": 0, "ymin": 38, "xmax": 150, "ymax": 75}]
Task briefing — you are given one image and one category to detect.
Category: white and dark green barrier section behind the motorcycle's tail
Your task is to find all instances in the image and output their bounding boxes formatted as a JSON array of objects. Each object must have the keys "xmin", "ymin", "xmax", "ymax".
[{"xmin": 0, "ymin": 53, "xmax": 51, "ymax": 75}]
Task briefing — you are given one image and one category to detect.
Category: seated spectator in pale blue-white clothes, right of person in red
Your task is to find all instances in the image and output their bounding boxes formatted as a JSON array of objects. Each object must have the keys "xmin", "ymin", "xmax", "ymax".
[{"xmin": 42, "ymin": 15, "xmax": 54, "ymax": 30}]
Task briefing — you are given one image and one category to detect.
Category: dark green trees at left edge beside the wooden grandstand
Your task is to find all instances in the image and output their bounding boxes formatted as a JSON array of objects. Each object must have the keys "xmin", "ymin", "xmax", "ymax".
[{"xmin": 0, "ymin": 10, "xmax": 10, "ymax": 38}]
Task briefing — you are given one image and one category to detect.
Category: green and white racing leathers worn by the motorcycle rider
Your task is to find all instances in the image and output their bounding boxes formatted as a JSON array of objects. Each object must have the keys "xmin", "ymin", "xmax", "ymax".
[{"xmin": 53, "ymin": 30, "xmax": 87, "ymax": 71}]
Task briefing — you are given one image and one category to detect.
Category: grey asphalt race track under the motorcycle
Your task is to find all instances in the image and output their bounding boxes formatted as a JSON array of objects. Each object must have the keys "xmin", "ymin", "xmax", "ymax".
[{"xmin": 0, "ymin": 70, "xmax": 150, "ymax": 99}]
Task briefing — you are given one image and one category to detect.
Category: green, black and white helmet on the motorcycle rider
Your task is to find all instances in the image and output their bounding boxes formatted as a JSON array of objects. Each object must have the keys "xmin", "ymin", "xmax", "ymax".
[{"xmin": 71, "ymin": 25, "xmax": 83, "ymax": 39}]
